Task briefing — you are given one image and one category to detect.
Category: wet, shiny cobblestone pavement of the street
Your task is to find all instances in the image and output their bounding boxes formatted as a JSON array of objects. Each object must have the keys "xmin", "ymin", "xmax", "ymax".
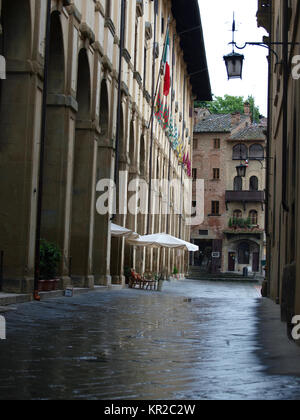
[{"xmin": 0, "ymin": 281, "xmax": 300, "ymax": 400}]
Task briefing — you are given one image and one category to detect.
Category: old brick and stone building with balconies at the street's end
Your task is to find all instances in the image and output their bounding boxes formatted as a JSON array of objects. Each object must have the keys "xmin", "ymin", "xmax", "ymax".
[{"xmin": 191, "ymin": 104, "xmax": 266, "ymax": 273}]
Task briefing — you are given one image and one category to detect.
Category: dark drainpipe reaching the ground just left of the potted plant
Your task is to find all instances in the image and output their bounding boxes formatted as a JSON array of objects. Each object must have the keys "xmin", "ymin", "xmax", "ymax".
[{"xmin": 34, "ymin": 0, "xmax": 51, "ymax": 301}]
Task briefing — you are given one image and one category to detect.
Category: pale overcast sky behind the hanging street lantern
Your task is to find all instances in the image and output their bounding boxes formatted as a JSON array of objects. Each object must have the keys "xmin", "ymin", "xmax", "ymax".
[{"xmin": 199, "ymin": 0, "xmax": 268, "ymax": 116}]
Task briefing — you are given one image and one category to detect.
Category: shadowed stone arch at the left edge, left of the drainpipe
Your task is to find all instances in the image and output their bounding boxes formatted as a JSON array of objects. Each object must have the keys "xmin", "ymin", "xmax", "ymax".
[{"xmin": 0, "ymin": 0, "xmax": 34, "ymax": 292}]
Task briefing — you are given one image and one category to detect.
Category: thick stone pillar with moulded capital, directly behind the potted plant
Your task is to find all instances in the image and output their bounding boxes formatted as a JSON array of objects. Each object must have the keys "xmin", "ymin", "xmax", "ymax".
[{"xmin": 42, "ymin": 94, "xmax": 77, "ymax": 289}]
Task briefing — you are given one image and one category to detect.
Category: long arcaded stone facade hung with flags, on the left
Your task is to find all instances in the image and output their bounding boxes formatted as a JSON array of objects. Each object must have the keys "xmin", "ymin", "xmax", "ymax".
[{"xmin": 0, "ymin": 0, "xmax": 210, "ymax": 292}]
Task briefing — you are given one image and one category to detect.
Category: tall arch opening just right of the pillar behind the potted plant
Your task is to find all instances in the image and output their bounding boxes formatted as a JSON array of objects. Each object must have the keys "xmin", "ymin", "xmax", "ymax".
[{"xmin": 71, "ymin": 48, "xmax": 95, "ymax": 287}]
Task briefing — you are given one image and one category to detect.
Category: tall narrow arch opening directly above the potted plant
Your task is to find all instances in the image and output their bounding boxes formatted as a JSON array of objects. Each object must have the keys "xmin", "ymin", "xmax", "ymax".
[{"xmin": 42, "ymin": 11, "xmax": 68, "ymax": 256}]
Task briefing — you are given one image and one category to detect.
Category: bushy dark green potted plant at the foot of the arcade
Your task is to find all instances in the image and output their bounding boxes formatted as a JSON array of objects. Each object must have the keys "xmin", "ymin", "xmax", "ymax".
[{"xmin": 39, "ymin": 239, "xmax": 62, "ymax": 292}]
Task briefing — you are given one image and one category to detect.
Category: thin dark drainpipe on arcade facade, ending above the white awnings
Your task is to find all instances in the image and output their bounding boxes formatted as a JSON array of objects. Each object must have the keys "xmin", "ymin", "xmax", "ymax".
[{"xmin": 111, "ymin": 0, "xmax": 126, "ymax": 221}]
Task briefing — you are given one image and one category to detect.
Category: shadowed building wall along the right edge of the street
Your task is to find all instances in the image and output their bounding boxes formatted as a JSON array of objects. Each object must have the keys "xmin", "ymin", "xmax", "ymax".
[{"xmin": 258, "ymin": 0, "xmax": 300, "ymax": 331}]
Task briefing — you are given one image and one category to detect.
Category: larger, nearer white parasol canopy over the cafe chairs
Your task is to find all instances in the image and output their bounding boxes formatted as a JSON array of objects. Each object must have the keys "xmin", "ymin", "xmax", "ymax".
[{"xmin": 128, "ymin": 233, "xmax": 199, "ymax": 252}]
